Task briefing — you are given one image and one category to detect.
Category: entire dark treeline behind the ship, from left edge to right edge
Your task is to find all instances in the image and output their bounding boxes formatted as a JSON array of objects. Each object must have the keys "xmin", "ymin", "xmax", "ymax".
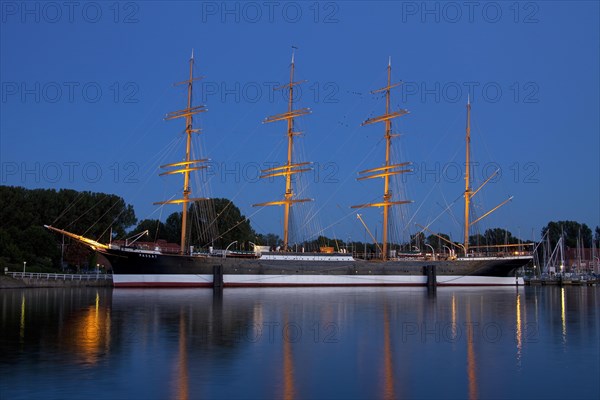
[{"xmin": 0, "ymin": 186, "xmax": 600, "ymax": 270}]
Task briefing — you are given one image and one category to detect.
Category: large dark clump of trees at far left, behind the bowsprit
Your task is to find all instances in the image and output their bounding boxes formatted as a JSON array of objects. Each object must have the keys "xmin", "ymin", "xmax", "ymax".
[{"xmin": 0, "ymin": 186, "xmax": 137, "ymax": 271}]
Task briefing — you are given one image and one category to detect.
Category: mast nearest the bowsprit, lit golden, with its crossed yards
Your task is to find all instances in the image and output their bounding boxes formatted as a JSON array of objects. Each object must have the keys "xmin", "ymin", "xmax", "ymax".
[{"xmin": 154, "ymin": 50, "xmax": 208, "ymax": 254}]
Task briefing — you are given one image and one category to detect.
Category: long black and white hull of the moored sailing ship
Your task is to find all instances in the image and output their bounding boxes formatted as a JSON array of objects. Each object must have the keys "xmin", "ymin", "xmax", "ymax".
[{"xmin": 102, "ymin": 249, "xmax": 530, "ymax": 287}]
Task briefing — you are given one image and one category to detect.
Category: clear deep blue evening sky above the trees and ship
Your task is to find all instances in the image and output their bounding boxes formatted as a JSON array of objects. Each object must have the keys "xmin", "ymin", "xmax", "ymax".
[{"xmin": 0, "ymin": 1, "xmax": 600, "ymax": 244}]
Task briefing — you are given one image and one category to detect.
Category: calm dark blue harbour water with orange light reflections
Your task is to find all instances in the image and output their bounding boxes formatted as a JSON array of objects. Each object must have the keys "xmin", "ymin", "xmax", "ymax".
[{"xmin": 0, "ymin": 287, "xmax": 600, "ymax": 399}]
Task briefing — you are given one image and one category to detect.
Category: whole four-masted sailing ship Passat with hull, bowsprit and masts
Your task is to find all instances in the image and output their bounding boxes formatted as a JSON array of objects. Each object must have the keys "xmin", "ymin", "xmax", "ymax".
[{"xmin": 46, "ymin": 53, "xmax": 531, "ymax": 287}]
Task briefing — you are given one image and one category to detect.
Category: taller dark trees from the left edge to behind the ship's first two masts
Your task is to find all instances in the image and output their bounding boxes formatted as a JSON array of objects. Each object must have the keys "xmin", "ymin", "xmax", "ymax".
[{"xmin": 0, "ymin": 186, "xmax": 281, "ymax": 272}]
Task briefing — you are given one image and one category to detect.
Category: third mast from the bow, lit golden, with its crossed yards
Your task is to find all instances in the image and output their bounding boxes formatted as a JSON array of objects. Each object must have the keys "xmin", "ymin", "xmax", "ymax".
[{"xmin": 352, "ymin": 57, "xmax": 411, "ymax": 261}]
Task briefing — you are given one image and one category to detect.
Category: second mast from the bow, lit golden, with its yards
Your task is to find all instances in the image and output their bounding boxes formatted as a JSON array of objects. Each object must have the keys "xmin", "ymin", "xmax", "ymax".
[{"xmin": 253, "ymin": 47, "xmax": 311, "ymax": 251}]
